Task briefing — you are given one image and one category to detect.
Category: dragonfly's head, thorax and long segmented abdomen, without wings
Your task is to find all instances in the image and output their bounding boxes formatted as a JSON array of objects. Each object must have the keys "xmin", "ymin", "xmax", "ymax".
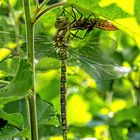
[{"xmin": 53, "ymin": 16, "xmax": 69, "ymax": 140}]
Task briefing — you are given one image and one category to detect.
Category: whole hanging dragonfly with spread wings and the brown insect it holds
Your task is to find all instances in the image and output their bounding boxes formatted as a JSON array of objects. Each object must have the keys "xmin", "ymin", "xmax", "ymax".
[{"xmin": 0, "ymin": 7, "xmax": 126, "ymax": 140}]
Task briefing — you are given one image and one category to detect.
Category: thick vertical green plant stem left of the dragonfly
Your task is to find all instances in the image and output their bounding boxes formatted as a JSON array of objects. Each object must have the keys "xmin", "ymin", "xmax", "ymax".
[{"xmin": 23, "ymin": 0, "xmax": 38, "ymax": 140}]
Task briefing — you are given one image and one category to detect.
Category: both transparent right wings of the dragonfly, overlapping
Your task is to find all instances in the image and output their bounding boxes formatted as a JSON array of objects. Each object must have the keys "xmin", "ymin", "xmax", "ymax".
[{"xmin": 69, "ymin": 35, "xmax": 128, "ymax": 80}]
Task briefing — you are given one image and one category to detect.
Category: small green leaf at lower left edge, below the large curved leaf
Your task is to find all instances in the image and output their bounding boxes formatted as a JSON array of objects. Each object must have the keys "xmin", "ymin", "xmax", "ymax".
[{"xmin": 0, "ymin": 109, "xmax": 23, "ymax": 128}]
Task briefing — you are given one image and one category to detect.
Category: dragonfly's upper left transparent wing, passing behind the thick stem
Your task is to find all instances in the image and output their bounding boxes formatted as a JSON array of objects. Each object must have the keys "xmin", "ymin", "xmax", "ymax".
[{"xmin": 0, "ymin": 31, "xmax": 53, "ymax": 58}]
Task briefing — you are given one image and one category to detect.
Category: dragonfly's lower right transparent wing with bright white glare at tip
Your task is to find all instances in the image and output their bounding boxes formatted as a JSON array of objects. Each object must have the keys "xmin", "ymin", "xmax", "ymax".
[{"xmin": 80, "ymin": 56, "xmax": 126, "ymax": 80}]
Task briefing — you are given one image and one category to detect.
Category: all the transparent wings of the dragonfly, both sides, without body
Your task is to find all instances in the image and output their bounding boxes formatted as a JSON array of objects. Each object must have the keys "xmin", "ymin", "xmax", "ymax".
[{"xmin": 0, "ymin": 30, "xmax": 127, "ymax": 79}]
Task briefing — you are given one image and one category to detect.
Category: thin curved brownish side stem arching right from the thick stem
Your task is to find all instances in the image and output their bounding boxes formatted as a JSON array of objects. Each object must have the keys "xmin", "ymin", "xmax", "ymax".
[{"xmin": 32, "ymin": 2, "xmax": 66, "ymax": 24}]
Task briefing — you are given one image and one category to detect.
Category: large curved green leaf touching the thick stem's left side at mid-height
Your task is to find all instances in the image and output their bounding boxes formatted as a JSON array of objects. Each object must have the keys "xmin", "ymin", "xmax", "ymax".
[{"xmin": 0, "ymin": 59, "xmax": 32, "ymax": 108}]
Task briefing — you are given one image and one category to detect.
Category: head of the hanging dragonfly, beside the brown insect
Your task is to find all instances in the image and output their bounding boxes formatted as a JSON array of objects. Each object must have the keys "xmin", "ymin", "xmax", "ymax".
[{"xmin": 55, "ymin": 16, "xmax": 68, "ymax": 29}]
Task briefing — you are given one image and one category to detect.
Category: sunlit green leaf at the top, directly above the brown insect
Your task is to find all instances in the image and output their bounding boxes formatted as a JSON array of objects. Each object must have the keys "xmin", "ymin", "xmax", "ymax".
[{"xmin": 68, "ymin": 0, "xmax": 130, "ymax": 20}]
